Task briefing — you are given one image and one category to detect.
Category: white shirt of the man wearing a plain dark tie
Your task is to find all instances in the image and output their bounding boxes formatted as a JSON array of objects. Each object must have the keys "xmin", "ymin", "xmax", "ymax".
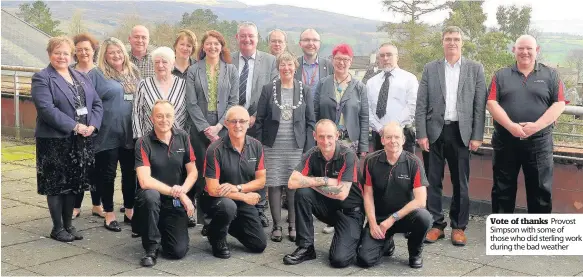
[{"xmin": 366, "ymin": 68, "xmax": 419, "ymax": 132}]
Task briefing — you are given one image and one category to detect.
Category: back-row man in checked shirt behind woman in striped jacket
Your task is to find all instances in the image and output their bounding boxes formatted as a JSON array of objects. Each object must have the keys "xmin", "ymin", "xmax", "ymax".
[{"xmin": 128, "ymin": 25, "xmax": 154, "ymax": 79}]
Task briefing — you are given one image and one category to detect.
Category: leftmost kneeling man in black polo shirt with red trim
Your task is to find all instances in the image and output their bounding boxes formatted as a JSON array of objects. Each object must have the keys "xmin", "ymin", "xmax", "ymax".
[{"xmin": 133, "ymin": 100, "xmax": 198, "ymax": 267}]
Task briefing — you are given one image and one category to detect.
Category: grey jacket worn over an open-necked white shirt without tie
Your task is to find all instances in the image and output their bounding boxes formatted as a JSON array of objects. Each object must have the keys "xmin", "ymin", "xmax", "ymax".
[{"xmin": 415, "ymin": 57, "xmax": 487, "ymax": 146}]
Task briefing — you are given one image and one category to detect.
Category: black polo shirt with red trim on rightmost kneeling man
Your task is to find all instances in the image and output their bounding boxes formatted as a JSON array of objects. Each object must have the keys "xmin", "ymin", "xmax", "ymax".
[{"xmin": 362, "ymin": 150, "xmax": 429, "ymax": 221}]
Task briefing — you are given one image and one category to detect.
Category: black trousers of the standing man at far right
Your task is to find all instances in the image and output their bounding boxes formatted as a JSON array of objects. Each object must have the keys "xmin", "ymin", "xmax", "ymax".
[{"xmin": 492, "ymin": 129, "xmax": 553, "ymax": 213}]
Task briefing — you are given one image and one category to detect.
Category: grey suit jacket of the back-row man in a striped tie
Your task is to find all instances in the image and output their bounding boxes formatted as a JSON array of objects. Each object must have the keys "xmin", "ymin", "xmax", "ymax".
[{"xmin": 233, "ymin": 50, "xmax": 279, "ymax": 115}]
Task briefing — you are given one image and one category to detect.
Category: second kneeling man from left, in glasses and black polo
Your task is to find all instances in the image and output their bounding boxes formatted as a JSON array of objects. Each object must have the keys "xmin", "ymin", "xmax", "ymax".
[{"xmin": 201, "ymin": 106, "xmax": 268, "ymax": 259}]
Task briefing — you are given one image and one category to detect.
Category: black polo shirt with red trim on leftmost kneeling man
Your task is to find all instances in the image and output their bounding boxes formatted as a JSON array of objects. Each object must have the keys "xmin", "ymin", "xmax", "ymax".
[{"xmin": 135, "ymin": 128, "xmax": 196, "ymax": 186}]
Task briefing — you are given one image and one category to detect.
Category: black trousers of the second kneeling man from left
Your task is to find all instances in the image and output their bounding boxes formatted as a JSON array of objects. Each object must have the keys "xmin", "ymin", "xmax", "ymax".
[{"xmin": 202, "ymin": 193, "xmax": 267, "ymax": 253}]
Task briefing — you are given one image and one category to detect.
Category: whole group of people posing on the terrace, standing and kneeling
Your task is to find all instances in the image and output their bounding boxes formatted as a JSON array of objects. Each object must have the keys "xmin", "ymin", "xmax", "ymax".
[{"xmin": 32, "ymin": 22, "xmax": 565, "ymax": 268}]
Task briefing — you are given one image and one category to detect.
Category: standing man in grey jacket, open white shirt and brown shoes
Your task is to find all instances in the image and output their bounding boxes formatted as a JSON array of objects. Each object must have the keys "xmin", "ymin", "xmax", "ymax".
[{"xmin": 415, "ymin": 26, "xmax": 486, "ymax": 246}]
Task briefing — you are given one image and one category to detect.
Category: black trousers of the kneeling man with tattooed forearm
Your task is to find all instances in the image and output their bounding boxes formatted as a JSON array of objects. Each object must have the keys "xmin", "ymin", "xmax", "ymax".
[{"xmin": 295, "ymin": 188, "xmax": 364, "ymax": 268}]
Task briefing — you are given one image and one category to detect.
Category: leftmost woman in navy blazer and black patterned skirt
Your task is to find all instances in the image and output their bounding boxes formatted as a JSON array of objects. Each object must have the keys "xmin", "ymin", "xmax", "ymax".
[{"xmin": 31, "ymin": 37, "xmax": 103, "ymax": 242}]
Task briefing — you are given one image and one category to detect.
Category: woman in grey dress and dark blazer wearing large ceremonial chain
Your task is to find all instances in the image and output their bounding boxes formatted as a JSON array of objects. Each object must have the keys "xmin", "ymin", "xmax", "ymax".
[{"xmin": 255, "ymin": 52, "xmax": 316, "ymax": 242}]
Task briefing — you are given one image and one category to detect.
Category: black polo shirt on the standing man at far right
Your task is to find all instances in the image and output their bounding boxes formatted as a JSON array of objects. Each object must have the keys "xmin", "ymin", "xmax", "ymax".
[{"xmin": 488, "ymin": 62, "xmax": 565, "ymax": 134}]
